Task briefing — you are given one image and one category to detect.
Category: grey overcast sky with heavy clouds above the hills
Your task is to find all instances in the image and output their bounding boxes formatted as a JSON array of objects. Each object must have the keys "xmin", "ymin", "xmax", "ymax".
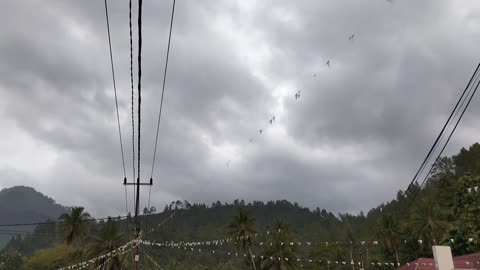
[{"xmin": 0, "ymin": 0, "xmax": 480, "ymax": 216}]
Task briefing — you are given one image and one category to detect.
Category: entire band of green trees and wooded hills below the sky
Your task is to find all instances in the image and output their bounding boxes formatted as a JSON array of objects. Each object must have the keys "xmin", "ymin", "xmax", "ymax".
[{"xmin": 0, "ymin": 144, "xmax": 480, "ymax": 270}]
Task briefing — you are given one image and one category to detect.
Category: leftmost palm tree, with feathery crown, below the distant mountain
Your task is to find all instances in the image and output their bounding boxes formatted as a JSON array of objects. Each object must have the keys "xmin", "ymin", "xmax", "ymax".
[{"xmin": 58, "ymin": 207, "xmax": 91, "ymax": 245}]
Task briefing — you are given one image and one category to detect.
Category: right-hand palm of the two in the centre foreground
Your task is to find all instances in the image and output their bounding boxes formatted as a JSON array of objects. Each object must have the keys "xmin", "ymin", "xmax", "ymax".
[{"xmin": 262, "ymin": 219, "xmax": 298, "ymax": 270}]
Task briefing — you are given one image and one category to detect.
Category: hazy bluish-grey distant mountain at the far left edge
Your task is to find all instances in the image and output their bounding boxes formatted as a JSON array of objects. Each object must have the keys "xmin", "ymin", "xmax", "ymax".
[{"xmin": 0, "ymin": 186, "xmax": 66, "ymax": 249}]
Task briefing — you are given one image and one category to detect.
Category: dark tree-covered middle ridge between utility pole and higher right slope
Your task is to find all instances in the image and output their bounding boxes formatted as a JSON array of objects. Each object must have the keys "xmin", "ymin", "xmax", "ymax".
[{"xmin": 146, "ymin": 200, "xmax": 356, "ymax": 243}]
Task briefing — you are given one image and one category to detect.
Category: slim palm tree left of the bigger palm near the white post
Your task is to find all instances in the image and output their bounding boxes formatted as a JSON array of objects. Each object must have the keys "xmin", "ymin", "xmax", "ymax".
[{"xmin": 378, "ymin": 214, "xmax": 400, "ymax": 265}]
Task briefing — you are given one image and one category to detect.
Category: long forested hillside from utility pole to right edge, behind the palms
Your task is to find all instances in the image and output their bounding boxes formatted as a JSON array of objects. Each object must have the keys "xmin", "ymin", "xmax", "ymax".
[{"xmin": 131, "ymin": 141, "xmax": 480, "ymax": 269}]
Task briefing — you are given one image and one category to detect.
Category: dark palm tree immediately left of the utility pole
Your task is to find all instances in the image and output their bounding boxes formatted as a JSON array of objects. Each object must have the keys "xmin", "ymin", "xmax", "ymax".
[{"xmin": 89, "ymin": 218, "xmax": 125, "ymax": 270}]
